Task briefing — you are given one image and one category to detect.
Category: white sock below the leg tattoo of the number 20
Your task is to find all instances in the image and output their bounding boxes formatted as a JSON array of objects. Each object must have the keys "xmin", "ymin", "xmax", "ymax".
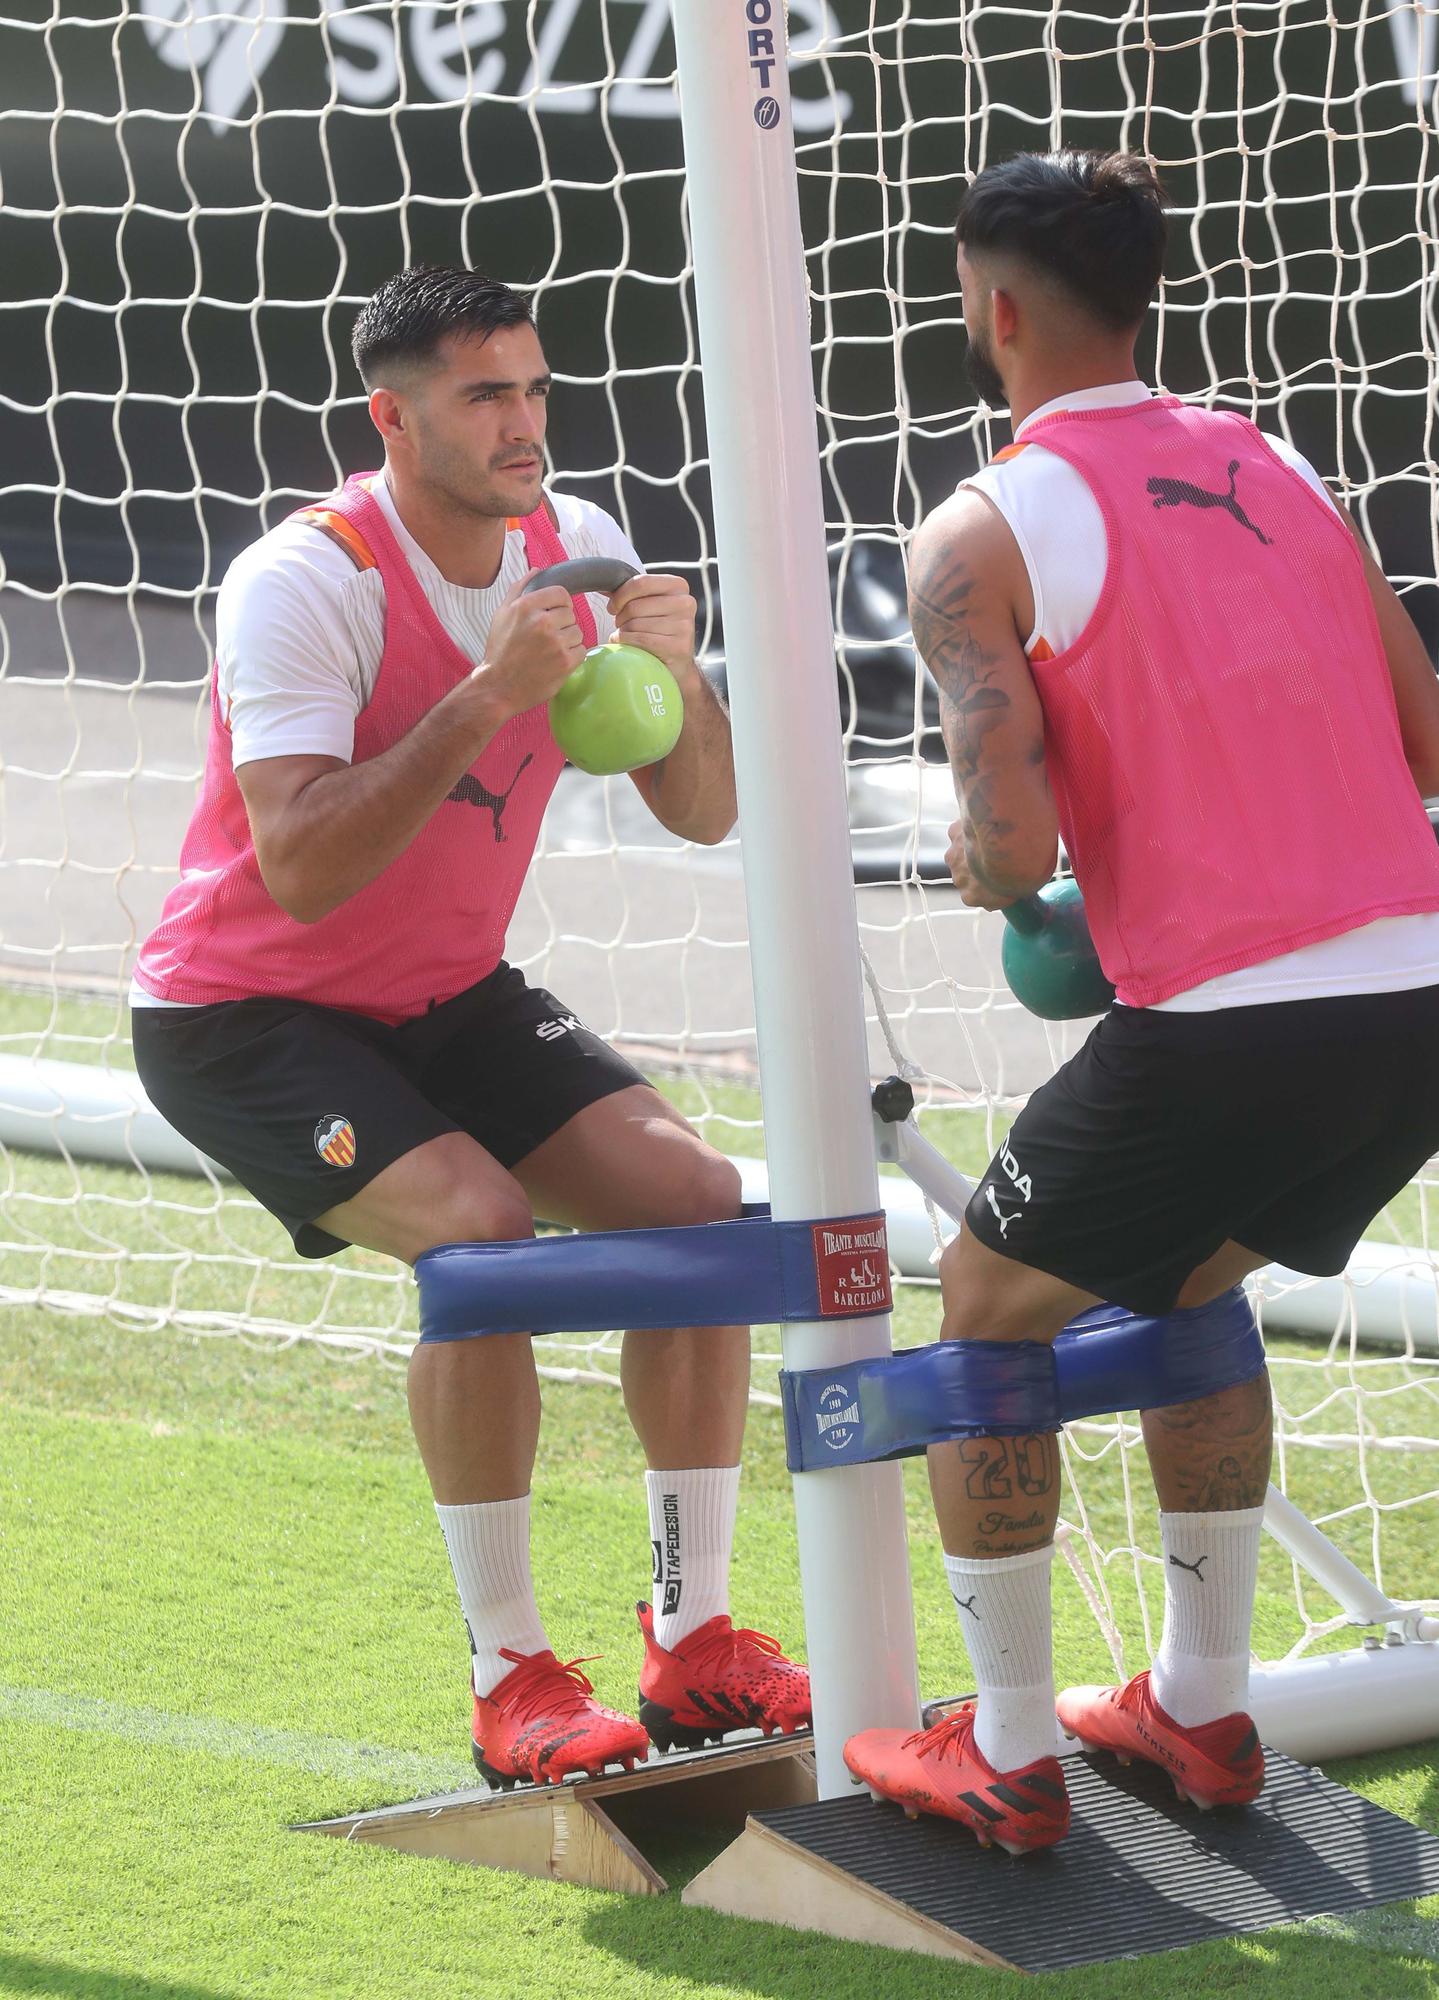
[{"xmin": 945, "ymin": 1544, "xmax": 1059, "ymax": 1770}]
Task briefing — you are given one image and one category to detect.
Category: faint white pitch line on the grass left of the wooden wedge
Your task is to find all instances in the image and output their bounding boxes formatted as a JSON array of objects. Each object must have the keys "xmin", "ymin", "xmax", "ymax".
[{"xmin": 0, "ymin": 1686, "xmax": 478, "ymax": 1798}]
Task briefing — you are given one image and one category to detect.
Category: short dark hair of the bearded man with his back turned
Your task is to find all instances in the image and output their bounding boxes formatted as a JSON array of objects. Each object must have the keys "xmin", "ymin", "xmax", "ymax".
[{"xmin": 955, "ymin": 152, "xmax": 1169, "ymax": 332}]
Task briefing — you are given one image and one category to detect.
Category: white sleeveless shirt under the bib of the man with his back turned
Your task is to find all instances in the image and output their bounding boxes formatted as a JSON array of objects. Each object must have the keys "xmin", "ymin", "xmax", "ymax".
[{"xmin": 961, "ymin": 382, "xmax": 1439, "ymax": 1014}]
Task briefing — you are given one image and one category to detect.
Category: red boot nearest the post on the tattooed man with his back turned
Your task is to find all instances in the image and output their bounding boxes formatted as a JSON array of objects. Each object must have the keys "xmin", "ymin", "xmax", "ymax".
[{"xmin": 845, "ymin": 1702, "xmax": 1069, "ymax": 1854}]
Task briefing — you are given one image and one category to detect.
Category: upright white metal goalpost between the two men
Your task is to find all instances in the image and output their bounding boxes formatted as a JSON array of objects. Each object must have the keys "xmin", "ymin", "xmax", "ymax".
[{"xmin": 674, "ymin": 0, "xmax": 919, "ymax": 1798}]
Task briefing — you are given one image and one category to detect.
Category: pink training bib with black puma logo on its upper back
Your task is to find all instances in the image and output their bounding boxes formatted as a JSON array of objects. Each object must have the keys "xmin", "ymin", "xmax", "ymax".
[{"xmin": 1023, "ymin": 396, "xmax": 1439, "ymax": 1006}]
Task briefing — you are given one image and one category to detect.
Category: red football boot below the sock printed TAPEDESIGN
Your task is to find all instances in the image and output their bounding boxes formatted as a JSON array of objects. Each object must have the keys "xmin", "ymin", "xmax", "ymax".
[{"xmin": 636, "ymin": 1604, "xmax": 809, "ymax": 1750}]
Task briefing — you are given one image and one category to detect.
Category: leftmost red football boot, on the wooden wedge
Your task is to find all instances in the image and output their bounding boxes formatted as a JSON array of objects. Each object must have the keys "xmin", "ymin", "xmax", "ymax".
[{"xmin": 472, "ymin": 1646, "xmax": 650, "ymax": 1792}]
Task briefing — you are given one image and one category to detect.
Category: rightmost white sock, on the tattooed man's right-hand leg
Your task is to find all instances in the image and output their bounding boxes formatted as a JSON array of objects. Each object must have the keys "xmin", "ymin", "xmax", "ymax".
[{"xmin": 1149, "ymin": 1506, "xmax": 1263, "ymax": 1728}]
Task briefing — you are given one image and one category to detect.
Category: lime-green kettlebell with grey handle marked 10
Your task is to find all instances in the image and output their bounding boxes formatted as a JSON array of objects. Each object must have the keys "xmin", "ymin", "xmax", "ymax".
[{"xmin": 526, "ymin": 556, "xmax": 684, "ymax": 778}]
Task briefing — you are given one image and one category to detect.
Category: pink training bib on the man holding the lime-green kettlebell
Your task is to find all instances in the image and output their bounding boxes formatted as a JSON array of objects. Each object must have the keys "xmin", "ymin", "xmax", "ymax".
[{"xmin": 136, "ymin": 472, "xmax": 596, "ymax": 1022}]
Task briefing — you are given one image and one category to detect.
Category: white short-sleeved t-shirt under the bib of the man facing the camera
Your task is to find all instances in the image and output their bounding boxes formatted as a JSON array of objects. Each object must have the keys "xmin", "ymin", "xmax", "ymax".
[{"xmin": 130, "ymin": 478, "xmax": 644, "ymax": 1006}]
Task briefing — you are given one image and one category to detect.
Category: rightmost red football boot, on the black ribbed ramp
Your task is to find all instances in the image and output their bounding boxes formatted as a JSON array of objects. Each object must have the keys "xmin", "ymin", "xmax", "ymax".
[{"xmin": 1055, "ymin": 1672, "xmax": 1263, "ymax": 1812}]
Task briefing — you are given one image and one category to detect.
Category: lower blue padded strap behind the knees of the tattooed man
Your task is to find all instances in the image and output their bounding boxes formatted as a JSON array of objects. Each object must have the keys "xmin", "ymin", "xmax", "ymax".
[{"xmin": 779, "ymin": 1288, "xmax": 1265, "ymax": 1472}]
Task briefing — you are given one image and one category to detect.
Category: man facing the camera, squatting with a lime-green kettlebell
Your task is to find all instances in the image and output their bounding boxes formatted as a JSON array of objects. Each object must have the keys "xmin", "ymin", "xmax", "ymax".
[{"xmin": 132, "ymin": 268, "xmax": 809, "ymax": 1786}]
